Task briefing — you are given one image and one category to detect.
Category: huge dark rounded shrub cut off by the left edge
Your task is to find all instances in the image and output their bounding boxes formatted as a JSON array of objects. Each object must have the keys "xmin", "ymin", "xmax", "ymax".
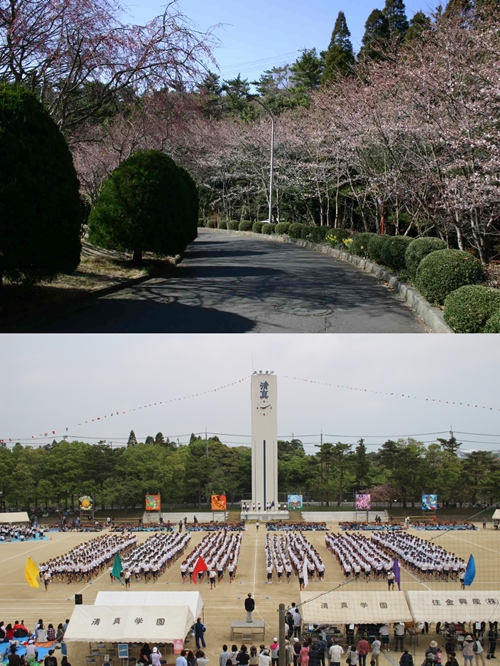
[{"xmin": 0, "ymin": 84, "xmax": 85, "ymax": 282}]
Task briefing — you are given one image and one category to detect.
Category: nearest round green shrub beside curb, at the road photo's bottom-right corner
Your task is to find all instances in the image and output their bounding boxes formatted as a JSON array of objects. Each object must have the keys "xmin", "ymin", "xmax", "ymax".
[{"xmin": 444, "ymin": 284, "xmax": 500, "ymax": 333}]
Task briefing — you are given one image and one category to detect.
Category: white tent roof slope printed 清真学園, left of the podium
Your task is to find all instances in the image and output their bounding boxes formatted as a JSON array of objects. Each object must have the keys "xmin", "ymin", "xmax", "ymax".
[{"xmin": 64, "ymin": 606, "xmax": 195, "ymax": 643}]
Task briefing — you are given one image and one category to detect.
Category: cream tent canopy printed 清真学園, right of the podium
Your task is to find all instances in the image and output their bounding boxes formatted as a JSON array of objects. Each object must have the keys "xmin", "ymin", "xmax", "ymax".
[{"xmin": 299, "ymin": 590, "xmax": 413, "ymax": 624}]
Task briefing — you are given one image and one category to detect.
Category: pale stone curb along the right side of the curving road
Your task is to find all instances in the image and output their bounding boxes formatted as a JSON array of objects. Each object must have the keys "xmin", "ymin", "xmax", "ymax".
[{"xmin": 200, "ymin": 227, "xmax": 453, "ymax": 333}]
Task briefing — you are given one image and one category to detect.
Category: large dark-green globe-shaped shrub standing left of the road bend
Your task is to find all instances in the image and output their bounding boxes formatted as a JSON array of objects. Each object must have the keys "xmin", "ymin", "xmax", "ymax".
[{"xmin": 89, "ymin": 150, "xmax": 198, "ymax": 263}]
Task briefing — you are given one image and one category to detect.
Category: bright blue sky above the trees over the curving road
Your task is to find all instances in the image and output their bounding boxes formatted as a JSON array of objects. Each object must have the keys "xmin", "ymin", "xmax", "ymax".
[{"xmin": 123, "ymin": 0, "xmax": 446, "ymax": 81}]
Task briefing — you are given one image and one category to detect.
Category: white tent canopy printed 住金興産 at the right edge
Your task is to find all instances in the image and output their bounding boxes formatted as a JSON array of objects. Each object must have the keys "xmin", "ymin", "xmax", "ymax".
[{"xmin": 406, "ymin": 590, "xmax": 500, "ymax": 622}]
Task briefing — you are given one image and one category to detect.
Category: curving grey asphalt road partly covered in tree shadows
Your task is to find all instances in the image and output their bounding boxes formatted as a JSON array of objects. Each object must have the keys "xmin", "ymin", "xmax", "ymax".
[{"xmin": 40, "ymin": 231, "xmax": 425, "ymax": 333}]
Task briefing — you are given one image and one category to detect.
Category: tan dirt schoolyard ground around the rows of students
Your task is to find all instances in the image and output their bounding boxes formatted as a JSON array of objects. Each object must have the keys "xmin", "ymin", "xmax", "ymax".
[{"xmin": 0, "ymin": 517, "xmax": 500, "ymax": 666}]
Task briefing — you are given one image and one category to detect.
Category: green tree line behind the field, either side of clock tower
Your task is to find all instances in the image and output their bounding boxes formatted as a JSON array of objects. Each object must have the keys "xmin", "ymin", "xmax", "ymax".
[{"xmin": 0, "ymin": 432, "xmax": 500, "ymax": 509}]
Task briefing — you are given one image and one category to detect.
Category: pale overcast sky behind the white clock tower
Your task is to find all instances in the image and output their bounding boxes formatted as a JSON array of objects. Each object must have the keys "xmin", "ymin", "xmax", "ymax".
[{"xmin": 0, "ymin": 335, "xmax": 500, "ymax": 453}]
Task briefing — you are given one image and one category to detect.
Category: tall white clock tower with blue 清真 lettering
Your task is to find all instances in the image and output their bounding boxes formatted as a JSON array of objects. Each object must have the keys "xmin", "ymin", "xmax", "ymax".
[{"xmin": 251, "ymin": 370, "xmax": 278, "ymax": 512}]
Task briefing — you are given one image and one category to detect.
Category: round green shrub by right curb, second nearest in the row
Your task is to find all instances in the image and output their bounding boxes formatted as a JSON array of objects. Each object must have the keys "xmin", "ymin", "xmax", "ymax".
[{"xmin": 415, "ymin": 250, "xmax": 484, "ymax": 304}]
